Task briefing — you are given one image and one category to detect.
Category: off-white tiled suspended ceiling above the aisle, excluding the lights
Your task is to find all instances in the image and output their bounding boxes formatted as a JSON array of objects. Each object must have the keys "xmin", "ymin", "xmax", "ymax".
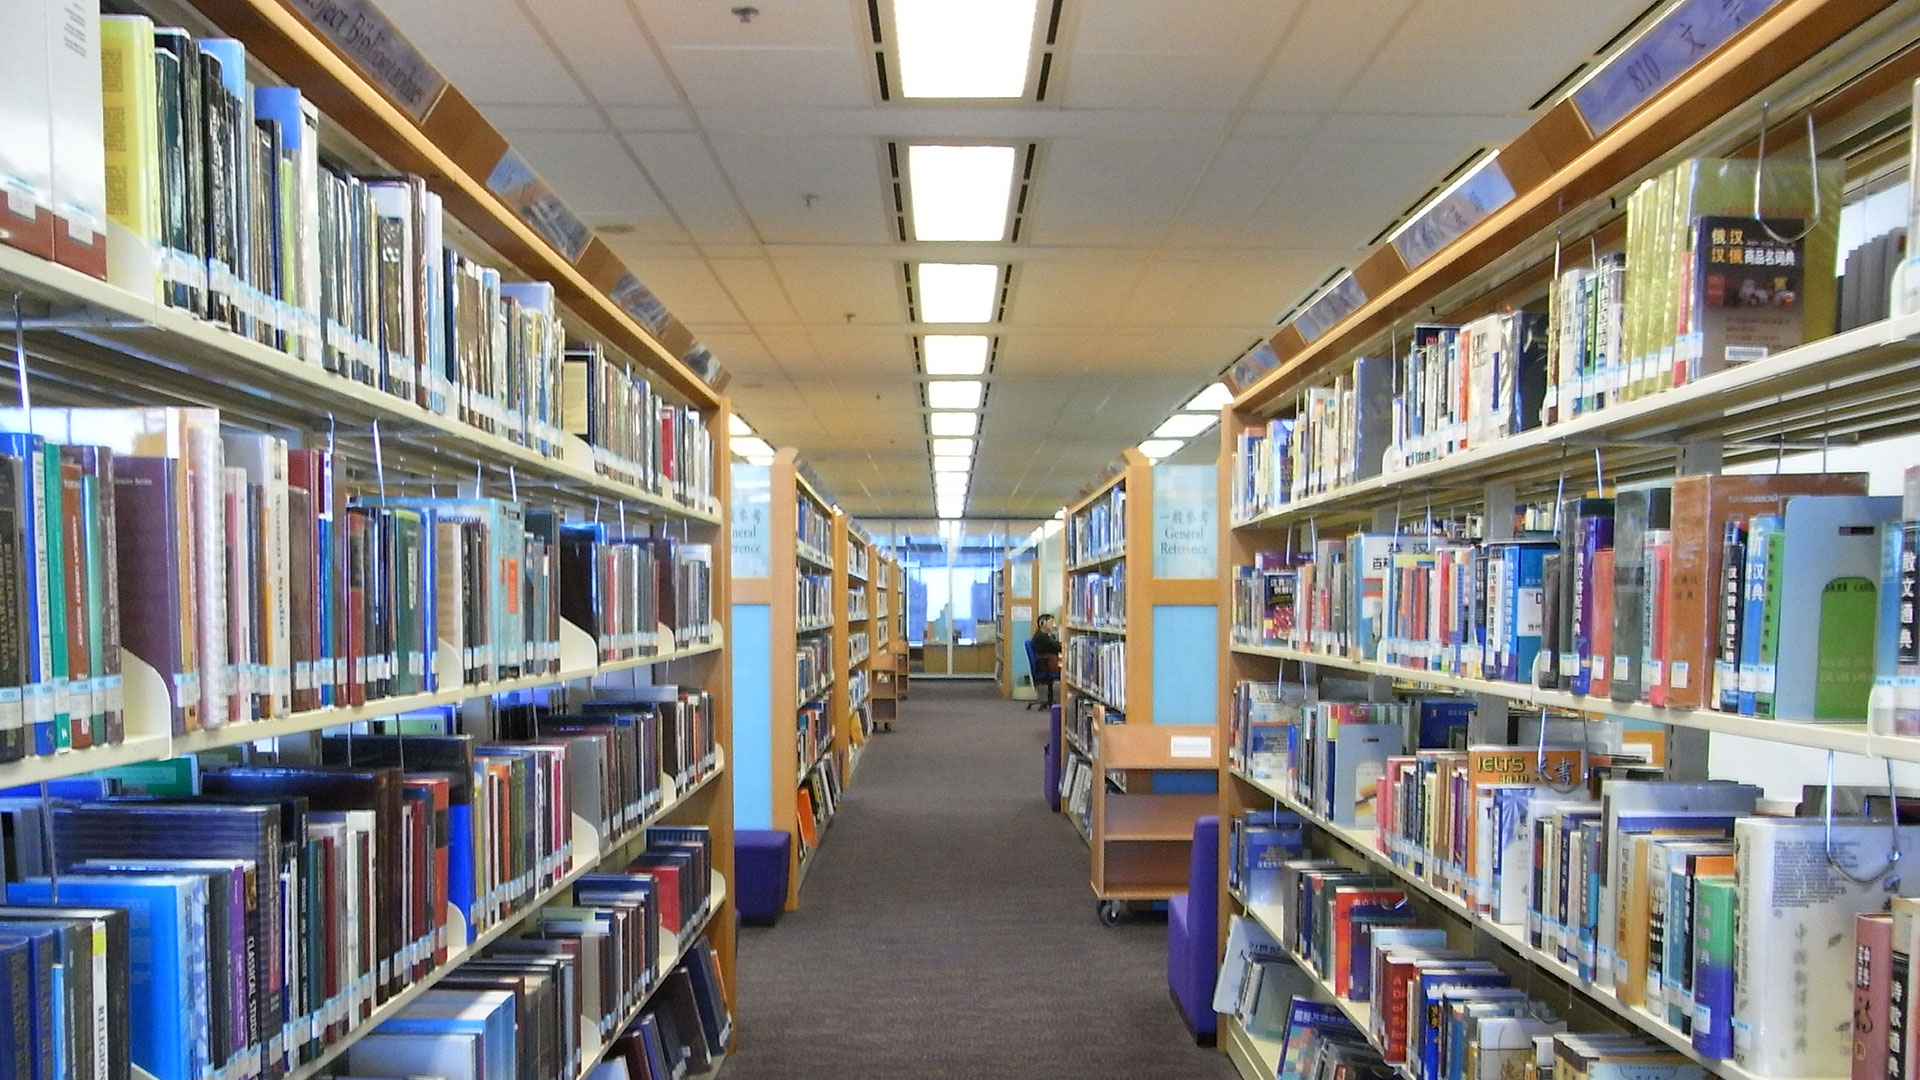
[{"xmin": 382, "ymin": 0, "xmax": 1645, "ymax": 517}]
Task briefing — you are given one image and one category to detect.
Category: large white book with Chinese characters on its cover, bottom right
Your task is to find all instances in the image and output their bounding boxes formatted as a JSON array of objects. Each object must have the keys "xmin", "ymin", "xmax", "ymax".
[{"xmin": 1732, "ymin": 817, "xmax": 1920, "ymax": 1076}]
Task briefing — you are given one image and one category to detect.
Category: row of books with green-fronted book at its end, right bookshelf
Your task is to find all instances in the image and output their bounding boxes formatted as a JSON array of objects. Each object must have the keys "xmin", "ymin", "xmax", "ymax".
[{"xmin": 1235, "ymin": 465, "xmax": 1920, "ymax": 722}]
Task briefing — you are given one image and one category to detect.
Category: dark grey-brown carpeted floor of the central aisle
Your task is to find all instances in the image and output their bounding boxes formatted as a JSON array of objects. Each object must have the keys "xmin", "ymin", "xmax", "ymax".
[{"xmin": 724, "ymin": 682, "xmax": 1235, "ymax": 1080}]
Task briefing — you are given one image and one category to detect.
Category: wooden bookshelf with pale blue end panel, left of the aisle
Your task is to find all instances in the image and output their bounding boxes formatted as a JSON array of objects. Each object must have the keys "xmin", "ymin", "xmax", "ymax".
[{"xmin": 733, "ymin": 448, "xmax": 847, "ymax": 911}]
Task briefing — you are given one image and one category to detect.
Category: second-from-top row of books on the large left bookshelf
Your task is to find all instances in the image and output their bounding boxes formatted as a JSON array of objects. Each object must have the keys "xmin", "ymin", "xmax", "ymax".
[{"xmin": 0, "ymin": 407, "xmax": 712, "ymax": 759}]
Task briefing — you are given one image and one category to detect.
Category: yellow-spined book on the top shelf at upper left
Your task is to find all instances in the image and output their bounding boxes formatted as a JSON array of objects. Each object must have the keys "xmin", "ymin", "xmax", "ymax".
[{"xmin": 100, "ymin": 15, "xmax": 161, "ymax": 300}]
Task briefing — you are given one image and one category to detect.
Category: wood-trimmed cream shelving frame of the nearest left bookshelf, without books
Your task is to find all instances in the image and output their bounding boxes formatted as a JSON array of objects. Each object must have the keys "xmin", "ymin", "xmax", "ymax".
[{"xmin": 0, "ymin": 0, "xmax": 735, "ymax": 1080}]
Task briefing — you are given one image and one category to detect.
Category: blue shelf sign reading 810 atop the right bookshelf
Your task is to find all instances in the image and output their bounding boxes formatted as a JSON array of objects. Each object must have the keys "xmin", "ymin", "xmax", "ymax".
[{"xmin": 1572, "ymin": 0, "xmax": 1780, "ymax": 136}]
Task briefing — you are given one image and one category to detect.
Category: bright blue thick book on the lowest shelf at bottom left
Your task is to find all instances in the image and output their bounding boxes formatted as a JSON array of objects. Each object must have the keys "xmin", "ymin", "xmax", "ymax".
[{"xmin": 0, "ymin": 874, "xmax": 209, "ymax": 1080}]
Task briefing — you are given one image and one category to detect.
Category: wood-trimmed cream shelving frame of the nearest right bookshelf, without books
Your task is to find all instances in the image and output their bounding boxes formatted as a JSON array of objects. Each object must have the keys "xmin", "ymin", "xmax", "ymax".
[{"xmin": 1217, "ymin": 0, "xmax": 1920, "ymax": 1080}]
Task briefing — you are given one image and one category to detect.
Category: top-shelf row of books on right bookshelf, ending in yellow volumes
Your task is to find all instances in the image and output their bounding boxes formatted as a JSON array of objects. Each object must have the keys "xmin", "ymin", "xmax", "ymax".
[{"xmin": 1233, "ymin": 158, "xmax": 1841, "ymax": 521}]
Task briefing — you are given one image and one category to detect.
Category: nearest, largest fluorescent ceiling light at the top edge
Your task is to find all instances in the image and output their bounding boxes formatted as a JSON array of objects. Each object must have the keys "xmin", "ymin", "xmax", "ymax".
[{"xmin": 893, "ymin": 0, "xmax": 1039, "ymax": 98}]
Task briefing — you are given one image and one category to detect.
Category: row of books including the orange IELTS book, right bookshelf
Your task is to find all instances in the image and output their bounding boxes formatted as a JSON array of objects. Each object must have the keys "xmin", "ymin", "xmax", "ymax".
[{"xmin": 1240, "ymin": 703, "xmax": 1920, "ymax": 1076}]
